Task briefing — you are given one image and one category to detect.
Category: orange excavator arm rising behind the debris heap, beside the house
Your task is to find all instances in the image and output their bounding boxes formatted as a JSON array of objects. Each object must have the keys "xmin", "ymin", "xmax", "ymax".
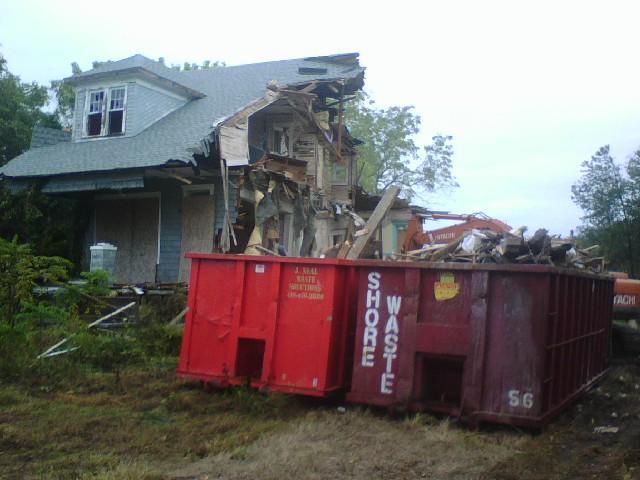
[{"xmin": 402, "ymin": 209, "xmax": 511, "ymax": 253}]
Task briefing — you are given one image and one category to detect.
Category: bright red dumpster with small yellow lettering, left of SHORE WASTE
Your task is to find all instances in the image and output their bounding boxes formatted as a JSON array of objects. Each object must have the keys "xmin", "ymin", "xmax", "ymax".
[{"xmin": 178, "ymin": 253, "xmax": 354, "ymax": 396}]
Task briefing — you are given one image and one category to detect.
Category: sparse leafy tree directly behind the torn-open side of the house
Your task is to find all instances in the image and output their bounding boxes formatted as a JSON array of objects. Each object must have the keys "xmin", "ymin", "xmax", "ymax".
[{"xmin": 345, "ymin": 93, "xmax": 457, "ymax": 198}]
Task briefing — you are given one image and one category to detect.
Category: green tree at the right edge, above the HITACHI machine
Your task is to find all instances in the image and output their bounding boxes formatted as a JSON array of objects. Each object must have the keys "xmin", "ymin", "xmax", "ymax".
[{"xmin": 571, "ymin": 145, "xmax": 640, "ymax": 276}]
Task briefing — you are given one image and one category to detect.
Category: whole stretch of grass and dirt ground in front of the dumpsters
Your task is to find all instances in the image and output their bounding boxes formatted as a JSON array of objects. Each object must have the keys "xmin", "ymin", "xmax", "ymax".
[{"xmin": 0, "ymin": 364, "xmax": 640, "ymax": 480}]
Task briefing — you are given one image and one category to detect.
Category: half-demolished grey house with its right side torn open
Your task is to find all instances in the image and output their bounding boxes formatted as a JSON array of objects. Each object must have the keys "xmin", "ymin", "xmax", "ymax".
[{"xmin": 0, "ymin": 53, "xmax": 364, "ymax": 284}]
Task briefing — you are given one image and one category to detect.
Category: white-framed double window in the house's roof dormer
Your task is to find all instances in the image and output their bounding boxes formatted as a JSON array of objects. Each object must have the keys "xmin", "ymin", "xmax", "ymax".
[{"xmin": 85, "ymin": 87, "xmax": 127, "ymax": 137}]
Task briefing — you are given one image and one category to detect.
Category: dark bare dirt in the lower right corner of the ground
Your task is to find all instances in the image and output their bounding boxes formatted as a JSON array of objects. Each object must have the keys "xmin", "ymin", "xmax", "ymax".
[{"xmin": 483, "ymin": 364, "xmax": 640, "ymax": 480}]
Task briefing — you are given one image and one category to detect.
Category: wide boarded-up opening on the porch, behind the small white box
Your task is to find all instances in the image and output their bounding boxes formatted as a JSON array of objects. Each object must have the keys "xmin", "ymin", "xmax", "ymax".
[{"xmin": 96, "ymin": 197, "xmax": 160, "ymax": 283}]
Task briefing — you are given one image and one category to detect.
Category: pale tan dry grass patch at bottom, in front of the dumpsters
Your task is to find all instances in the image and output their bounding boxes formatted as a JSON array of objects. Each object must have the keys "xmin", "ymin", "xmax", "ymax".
[{"xmin": 170, "ymin": 410, "xmax": 526, "ymax": 480}]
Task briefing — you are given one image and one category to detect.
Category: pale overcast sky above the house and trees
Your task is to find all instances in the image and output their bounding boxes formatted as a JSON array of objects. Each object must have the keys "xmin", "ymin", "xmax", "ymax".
[{"xmin": 0, "ymin": 0, "xmax": 640, "ymax": 234}]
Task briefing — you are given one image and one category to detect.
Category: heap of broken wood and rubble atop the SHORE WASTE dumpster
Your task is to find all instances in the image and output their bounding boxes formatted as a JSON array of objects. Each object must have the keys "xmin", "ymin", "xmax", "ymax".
[{"xmin": 397, "ymin": 227, "xmax": 604, "ymax": 272}]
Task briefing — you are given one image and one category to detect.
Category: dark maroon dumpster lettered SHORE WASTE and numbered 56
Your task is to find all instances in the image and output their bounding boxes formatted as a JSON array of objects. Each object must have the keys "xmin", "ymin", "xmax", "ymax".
[{"xmin": 348, "ymin": 261, "xmax": 613, "ymax": 426}]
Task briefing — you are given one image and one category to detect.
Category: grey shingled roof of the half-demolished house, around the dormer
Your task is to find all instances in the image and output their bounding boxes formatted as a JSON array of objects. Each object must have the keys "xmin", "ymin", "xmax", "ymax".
[{"xmin": 0, "ymin": 54, "xmax": 364, "ymax": 178}]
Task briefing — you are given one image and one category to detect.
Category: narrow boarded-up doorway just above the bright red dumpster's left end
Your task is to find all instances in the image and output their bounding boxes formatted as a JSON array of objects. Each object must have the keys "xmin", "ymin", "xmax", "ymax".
[{"xmin": 180, "ymin": 185, "xmax": 215, "ymax": 282}]
